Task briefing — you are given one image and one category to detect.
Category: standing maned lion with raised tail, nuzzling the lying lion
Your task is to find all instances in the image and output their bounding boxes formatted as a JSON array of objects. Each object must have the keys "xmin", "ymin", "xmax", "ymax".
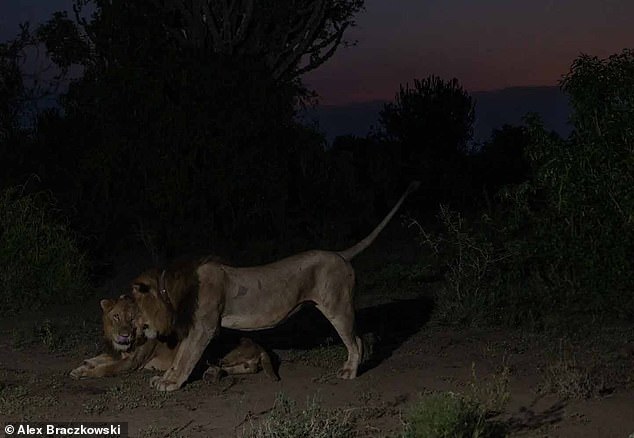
[{"xmin": 76, "ymin": 183, "xmax": 418, "ymax": 391}]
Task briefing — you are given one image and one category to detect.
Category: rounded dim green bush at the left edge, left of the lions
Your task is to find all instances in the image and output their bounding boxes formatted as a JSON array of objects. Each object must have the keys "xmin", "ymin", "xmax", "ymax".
[{"xmin": 0, "ymin": 188, "xmax": 90, "ymax": 314}]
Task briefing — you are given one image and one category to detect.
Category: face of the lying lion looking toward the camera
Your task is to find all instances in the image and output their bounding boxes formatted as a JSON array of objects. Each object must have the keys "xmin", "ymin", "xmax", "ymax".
[{"xmin": 100, "ymin": 295, "xmax": 142, "ymax": 351}]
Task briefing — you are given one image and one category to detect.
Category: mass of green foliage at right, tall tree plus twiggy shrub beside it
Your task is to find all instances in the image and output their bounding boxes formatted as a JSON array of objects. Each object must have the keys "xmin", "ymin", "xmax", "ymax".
[{"xmin": 425, "ymin": 50, "xmax": 634, "ymax": 328}]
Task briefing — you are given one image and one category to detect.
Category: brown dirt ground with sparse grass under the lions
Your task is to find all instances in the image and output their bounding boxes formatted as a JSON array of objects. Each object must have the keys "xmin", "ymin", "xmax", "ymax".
[{"xmin": 0, "ymin": 246, "xmax": 634, "ymax": 438}]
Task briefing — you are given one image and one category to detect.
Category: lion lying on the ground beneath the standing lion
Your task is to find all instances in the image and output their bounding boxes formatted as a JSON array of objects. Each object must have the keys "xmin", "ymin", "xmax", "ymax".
[{"xmin": 70, "ymin": 295, "xmax": 279, "ymax": 381}]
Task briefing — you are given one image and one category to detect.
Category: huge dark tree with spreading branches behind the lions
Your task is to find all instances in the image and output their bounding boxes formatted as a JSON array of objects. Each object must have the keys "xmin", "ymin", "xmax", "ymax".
[{"xmin": 29, "ymin": 0, "xmax": 363, "ymax": 255}]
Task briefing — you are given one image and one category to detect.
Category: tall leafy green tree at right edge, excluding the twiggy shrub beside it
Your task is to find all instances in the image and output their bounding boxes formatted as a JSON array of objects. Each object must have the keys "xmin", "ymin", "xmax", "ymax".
[{"xmin": 499, "ymin": 50, "xmax": 634, "ymax": 323}]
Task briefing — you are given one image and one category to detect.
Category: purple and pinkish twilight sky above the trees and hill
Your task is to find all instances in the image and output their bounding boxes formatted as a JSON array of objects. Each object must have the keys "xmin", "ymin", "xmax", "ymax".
[{"xmin": 0, "ymin": 0, "xmax": 634, "ymax": 105}]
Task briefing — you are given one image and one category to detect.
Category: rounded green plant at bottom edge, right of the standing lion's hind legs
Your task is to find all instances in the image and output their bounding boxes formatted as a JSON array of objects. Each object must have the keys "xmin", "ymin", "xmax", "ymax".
[{"xmin": 403, "ymin": 392, "xmax": 505, "ymax": 438}]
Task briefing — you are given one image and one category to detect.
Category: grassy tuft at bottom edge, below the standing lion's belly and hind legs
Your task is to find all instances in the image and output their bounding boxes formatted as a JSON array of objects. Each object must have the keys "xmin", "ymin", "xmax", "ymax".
[{"xmin": 242, "ymin": 393, "xmax": 354, "ymax": 438}]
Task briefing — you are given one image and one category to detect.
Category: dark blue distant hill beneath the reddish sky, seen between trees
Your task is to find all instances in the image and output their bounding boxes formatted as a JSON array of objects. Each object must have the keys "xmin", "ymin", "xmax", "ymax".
[{"xmin": 301, "ymin": 87, "xmax": 571, "ymax": 143}]
